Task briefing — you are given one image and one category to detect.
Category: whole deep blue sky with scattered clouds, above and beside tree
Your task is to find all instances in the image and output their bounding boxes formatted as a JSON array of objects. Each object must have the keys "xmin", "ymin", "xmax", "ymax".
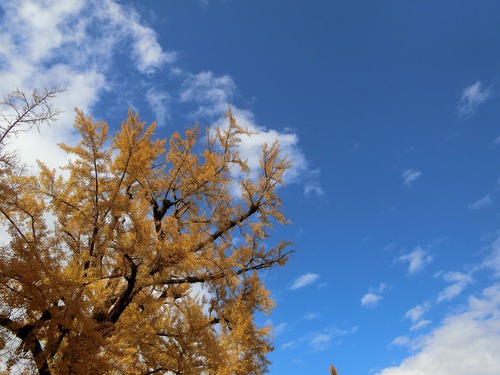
[{"xmin": 0, "ymin": 0, "xmax": 500, "ymax": 375}]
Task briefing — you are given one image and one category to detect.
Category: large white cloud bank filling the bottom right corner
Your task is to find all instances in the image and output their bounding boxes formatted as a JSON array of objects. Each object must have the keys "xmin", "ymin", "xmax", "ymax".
[{"xmin": 378, "ymin": 284, "xmax": 500, "ymax": 375}]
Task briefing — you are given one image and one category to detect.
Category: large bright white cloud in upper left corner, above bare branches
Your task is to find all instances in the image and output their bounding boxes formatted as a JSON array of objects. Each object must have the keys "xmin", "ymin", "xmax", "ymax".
[{"xmin": 0, "ymin": 0, "xmax": 174, "ymax": 167}]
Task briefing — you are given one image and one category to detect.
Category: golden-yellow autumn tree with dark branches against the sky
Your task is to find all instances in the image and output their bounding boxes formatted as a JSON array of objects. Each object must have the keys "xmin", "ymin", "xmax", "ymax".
[{"xmin": 0, "ymin": 90, "xmax": 290, "ymax": 375}]
